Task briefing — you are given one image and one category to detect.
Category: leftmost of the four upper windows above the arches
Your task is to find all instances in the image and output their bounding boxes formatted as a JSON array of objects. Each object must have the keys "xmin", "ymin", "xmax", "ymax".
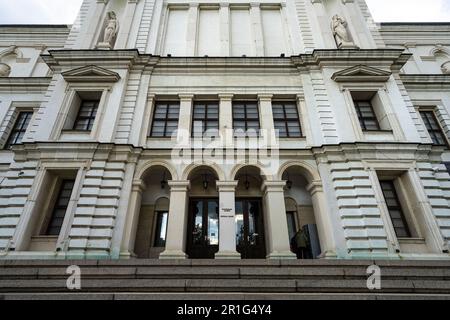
[{"xmin": 150, "ymin": 102, "xmax": 180, "ymax": 138}]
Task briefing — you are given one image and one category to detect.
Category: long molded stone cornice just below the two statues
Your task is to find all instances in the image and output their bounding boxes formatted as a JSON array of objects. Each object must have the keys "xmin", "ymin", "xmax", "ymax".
[{"xmin": 42, "ymin": 49, "xmax": 411, "ymax": 72}]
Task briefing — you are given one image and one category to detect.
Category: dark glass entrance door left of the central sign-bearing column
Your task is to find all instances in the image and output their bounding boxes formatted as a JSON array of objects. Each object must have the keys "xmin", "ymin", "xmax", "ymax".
[{"xmin": 187, "ymin": 199, "xmax": 219, "ymax": 259}]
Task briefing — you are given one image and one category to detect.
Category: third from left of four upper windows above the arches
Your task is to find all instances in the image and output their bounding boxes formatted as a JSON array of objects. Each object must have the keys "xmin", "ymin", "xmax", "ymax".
[{"xmin": 233, "ymin": 102, "xmax": 260, "ymax": 136}]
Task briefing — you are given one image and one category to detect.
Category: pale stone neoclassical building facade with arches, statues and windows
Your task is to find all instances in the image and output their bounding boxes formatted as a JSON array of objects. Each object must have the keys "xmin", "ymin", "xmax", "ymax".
[{"xmin": 0, "ymin": 0, "xmax": 450, "ymax": 259}]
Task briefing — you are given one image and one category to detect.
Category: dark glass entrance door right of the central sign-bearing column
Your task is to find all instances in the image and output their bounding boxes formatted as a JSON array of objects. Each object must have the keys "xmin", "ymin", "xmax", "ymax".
[{"xmin": 236, "ymin": 199, "xmax": 266, "ymax": 259}]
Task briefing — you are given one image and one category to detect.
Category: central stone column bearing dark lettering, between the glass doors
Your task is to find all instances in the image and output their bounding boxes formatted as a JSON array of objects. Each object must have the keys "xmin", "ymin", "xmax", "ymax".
[{"xmin": 216, "ymin": 181, "xmax": 241, "ymax": 259}]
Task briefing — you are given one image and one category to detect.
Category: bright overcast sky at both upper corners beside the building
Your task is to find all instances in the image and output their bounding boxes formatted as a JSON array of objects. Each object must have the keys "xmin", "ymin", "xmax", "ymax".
[{"xmin": 0, "ymin": 0, "xmax": 450, "ymax": 24}]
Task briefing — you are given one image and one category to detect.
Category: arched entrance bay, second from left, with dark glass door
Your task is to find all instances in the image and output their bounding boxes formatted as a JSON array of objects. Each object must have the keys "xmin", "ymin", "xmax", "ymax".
[{"xmin": 186, "ymin": 166, "xmax": 219, "ymax": 259}]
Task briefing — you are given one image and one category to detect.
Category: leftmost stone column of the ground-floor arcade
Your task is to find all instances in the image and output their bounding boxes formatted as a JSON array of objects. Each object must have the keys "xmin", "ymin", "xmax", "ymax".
[{"xmin": 120, "ymin": 180, "xmax": 145, "ymax": 259}]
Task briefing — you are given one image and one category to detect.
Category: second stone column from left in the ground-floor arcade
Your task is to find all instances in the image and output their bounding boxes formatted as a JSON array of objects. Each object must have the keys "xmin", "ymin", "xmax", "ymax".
[{"xmin": 159, "ymin": 181, "xmax": 189, "ymax": 259}]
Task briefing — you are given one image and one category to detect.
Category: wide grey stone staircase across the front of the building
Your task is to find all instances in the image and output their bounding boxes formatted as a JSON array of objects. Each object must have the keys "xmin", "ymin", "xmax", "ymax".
[{"xmin": 0, "ymin": 259, "xmax": 450, "ymax": 300}]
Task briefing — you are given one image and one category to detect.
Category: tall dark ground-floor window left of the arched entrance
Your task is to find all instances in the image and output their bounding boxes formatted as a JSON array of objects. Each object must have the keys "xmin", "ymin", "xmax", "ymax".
[{"xmin": 44, "ymin": 180, "xmax": 75, "ymax": 236}]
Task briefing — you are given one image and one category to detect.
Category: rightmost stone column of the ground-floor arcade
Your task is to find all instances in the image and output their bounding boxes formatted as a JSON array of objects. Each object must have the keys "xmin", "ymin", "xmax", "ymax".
[{"xmin": 306, "ymin": 181, "xmax": 336, "ymax": 258}]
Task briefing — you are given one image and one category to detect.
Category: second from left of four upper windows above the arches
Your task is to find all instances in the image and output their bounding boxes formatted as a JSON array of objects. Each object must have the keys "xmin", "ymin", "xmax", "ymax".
[{"xmin": 192, "ymin": 102, "xmax": 219, "ymax": 137}]
